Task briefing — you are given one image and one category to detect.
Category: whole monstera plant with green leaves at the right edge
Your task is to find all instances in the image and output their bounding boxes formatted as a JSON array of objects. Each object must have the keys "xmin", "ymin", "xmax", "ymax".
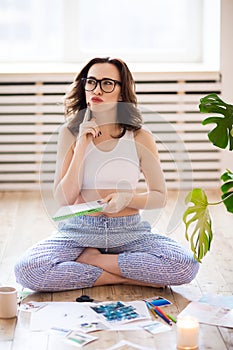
[{"xmin": 183, "ymin": 94, "xmax": 233, "ymax": 262}]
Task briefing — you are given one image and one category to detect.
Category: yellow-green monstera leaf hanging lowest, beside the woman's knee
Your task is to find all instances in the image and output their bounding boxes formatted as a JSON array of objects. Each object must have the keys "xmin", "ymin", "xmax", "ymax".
[{"xmin": 183, "ymin": 188, "xmax": 213, "ymax": 262}]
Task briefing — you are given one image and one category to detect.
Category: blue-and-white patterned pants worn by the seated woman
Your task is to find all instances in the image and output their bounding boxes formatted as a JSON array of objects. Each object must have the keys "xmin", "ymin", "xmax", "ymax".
[{"xmin": 15, "ymin": 215, "xmax": 199, "ymax": 291}]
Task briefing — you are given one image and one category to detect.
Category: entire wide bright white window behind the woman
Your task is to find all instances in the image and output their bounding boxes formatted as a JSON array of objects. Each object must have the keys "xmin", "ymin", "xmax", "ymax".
[{"xmin": 0, "ymin": 0, "xmax": 220, "ymax": 63}]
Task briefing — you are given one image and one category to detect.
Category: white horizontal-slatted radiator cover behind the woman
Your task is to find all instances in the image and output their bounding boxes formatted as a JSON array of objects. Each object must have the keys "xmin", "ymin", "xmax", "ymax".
[{"xmin": 0, "ymin": 72, "xmax": 222, "ymax": 190}]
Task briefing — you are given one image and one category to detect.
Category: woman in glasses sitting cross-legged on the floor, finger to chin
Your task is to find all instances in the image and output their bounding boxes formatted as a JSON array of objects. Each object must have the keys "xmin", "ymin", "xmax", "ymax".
[{"xmin": 15, "ymin": 58, "xmax": 199, "ymax": 291}]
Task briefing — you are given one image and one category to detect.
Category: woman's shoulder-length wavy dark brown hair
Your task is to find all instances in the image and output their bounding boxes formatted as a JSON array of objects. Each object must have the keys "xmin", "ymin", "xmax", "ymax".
[{"xmin": 64, "ymin": 57, "xmax": 142, "ymax": 137}]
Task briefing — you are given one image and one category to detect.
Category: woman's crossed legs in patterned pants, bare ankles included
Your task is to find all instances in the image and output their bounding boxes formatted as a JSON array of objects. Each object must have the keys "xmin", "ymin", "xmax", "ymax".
[{"xmin": 15, "ymin": 230, "xmax": 199, "ymax": 291}]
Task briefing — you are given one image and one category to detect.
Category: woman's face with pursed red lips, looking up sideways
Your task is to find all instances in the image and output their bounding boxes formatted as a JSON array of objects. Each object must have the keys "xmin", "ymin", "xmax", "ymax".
[{"xmin": 85, "ymin": 63, "xmax": 121, "ymax": 112}]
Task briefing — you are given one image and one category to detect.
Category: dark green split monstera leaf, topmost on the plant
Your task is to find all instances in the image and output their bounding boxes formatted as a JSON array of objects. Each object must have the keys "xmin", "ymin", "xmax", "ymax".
[{"xmin": 199, "ymin": 94, "xmax": 233, "ymax": 151}]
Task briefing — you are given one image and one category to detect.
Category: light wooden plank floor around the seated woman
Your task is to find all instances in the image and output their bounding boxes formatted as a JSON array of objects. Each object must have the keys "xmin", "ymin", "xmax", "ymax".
[{"xmin": 0, "ymin": 191, "xmax": 233, "ymax": 350}]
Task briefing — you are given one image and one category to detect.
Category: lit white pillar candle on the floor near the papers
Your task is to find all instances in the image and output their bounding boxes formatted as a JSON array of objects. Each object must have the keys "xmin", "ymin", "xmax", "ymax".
[{"xmin": 176, "ymin": 316, "xmax": 199, "ymax": 350}]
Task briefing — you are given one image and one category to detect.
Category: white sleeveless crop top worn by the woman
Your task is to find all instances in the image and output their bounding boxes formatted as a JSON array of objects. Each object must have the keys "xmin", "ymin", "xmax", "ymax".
[{"xmin": 82, "ymin": 130, "xmax": 140, "ymax": 190}]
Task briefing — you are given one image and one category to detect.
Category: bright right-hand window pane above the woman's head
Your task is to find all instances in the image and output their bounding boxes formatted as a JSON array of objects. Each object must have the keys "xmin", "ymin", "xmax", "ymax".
[{"xmin": 76, "ymin": 0, "xmax": 202, "ymax": 62}]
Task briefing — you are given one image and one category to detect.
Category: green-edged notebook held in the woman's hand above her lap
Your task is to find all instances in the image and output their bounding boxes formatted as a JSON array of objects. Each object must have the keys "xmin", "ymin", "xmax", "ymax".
[{"xmin": 52, "ymin": 201, "xmax": 106, "ymax": 221}]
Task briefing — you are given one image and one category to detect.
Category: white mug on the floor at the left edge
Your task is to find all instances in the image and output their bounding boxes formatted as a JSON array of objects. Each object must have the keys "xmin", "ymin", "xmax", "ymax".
[{"xmin": 0, "ymin": 287, "xmax": 17, "ymax": 318}]
